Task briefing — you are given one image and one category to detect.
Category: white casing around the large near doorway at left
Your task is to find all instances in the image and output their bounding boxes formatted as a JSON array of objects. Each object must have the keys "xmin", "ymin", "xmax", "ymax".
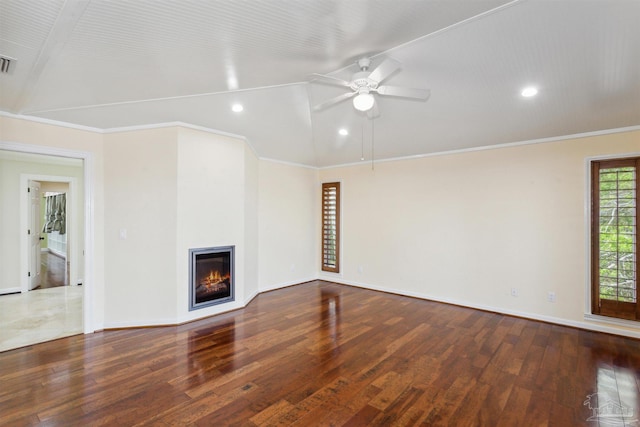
[{"xmin": 0, "ymin": 140, "xmax": 95, "ymax": 334}]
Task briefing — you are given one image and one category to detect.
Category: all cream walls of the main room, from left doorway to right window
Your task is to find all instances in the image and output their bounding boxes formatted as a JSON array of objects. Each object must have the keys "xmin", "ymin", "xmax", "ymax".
[{"xmin": 0, "ymin": 112, "xmax": 640, "ymax": 335}]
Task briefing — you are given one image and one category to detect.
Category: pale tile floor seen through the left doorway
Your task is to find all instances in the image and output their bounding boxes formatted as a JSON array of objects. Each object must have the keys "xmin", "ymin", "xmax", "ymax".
[{"xmin": 0, "ymin": 286, "xmax": 83, "ymax": 351}]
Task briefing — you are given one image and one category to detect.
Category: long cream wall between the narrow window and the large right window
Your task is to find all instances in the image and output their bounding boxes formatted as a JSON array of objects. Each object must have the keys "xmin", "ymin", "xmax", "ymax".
[{"xmin": 320, "ymin": 132, "xmax": 640, "ymax": 336}]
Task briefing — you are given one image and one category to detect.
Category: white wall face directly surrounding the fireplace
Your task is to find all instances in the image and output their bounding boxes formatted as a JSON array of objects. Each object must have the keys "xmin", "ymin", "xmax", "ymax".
[{"xmin": 174, "ymin": 129, "xmax": 258, "ymax": 322}]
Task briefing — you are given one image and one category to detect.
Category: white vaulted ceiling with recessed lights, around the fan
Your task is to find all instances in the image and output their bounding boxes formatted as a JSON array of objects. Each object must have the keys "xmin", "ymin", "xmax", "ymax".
[{"xmin": 0, "ymin": 0, "xmax": 640, "ymax": 167}]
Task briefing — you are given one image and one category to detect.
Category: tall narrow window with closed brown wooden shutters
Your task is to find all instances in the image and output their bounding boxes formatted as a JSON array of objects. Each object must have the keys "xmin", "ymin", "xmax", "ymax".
[{"xmin": 322, "ymin": 182, "xmax": 340, "ymax": 273}]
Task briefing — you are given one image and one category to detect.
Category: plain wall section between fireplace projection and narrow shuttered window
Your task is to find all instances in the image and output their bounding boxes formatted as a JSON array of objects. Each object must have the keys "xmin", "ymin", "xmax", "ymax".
[{"xmin": 259, "ymin": 160, "xmax": 320, "ymax": 291}]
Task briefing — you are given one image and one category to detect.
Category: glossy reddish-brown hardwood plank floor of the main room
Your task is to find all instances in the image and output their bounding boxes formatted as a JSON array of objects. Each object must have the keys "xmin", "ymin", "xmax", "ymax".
[{"xmin": 0, "ymin": 281, "xmax": 640, "ymax": 426}]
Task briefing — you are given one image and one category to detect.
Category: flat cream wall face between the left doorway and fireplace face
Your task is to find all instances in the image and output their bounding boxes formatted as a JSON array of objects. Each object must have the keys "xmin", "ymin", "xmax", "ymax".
[{"xmin": 104, "ymin": 128, "xmax": 178, "ymax": 327}]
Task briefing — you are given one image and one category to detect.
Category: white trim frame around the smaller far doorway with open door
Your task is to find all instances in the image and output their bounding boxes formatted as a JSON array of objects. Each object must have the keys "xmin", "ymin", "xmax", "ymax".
[{"xmin": 20, "ymin": 173, "xmax": 80, "ymax": 293}]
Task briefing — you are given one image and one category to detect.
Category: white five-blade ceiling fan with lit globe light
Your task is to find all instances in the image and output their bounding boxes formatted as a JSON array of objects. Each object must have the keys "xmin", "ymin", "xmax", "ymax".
[{"xmin": 313, "ymin": 58, "xmax": 431, "ymax": 118}]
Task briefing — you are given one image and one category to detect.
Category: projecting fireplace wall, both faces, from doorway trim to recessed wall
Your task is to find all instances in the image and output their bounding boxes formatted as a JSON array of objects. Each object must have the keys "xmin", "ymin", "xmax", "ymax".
[{"xmin": 105, "ymin": 127, "xmax": 258, "ymax": 328}]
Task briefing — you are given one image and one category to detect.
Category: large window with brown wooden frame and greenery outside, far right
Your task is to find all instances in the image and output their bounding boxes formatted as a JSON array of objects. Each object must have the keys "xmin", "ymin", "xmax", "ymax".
[{"xmin": 591, "ymin": 157, "xmax": 640, "ymax": 320}]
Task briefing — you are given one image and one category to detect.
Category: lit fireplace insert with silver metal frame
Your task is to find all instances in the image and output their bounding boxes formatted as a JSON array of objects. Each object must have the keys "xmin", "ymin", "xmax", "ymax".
[{"xmin": 189, "ymin": 246, "xmax": 235, "ymax": 311}]
